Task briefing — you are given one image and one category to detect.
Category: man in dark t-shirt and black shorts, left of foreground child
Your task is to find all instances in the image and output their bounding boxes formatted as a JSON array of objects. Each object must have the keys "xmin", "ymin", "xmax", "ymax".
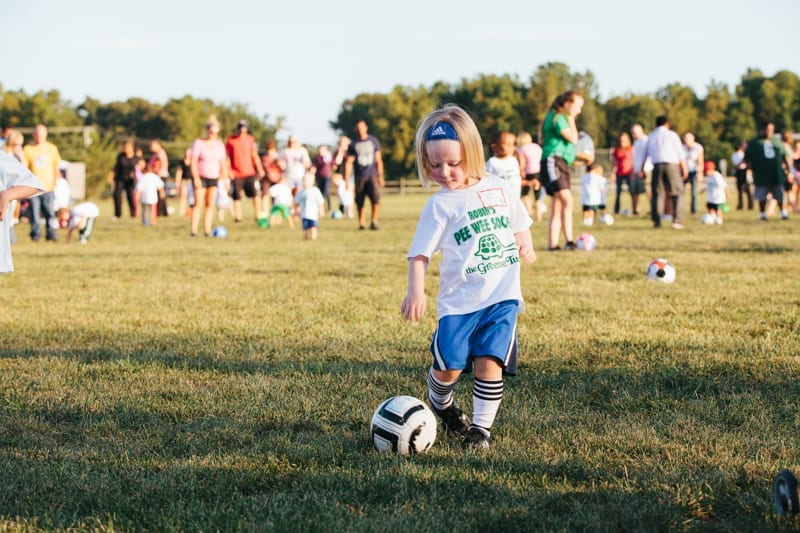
[{"xmin": 344, "ymin": 119, "xmax": 385, "ymax": 230}]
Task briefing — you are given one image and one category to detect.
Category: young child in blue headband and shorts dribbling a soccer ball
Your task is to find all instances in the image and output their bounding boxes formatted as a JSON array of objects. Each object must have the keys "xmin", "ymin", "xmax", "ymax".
[{"xmin": 400, "ymin": 105, "xmax": 536, "ymax": 448}]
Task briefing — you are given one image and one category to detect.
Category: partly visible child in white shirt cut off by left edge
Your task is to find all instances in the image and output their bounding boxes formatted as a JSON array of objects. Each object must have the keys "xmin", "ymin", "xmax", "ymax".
[{"xmin": 0, "ymin": 150, "xmax": 44, "ymax": 273}]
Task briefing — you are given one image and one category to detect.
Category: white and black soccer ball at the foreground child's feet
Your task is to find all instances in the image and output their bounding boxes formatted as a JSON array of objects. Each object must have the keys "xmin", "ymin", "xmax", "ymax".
[{"xmin": 369, "ymin": 396, "xmax": 436, "ymax": 455}]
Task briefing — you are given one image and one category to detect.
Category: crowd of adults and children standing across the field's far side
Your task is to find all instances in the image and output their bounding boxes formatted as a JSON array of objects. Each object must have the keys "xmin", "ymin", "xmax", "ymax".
[{"xmin": 0, "ymin": 103, "xmax": 800, "ymax": 251}]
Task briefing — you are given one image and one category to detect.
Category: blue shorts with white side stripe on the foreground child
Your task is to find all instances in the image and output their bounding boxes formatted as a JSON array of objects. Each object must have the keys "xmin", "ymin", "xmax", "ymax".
[{"xmin": 431, "ymin": 300, "xmax": 519, "ymax": 376}]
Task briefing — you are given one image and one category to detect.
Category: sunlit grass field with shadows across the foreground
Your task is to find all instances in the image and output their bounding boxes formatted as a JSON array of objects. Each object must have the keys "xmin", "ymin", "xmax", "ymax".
[{"xmin": 0, "ymin": 194, "xmax": 800, "ymax": 532}]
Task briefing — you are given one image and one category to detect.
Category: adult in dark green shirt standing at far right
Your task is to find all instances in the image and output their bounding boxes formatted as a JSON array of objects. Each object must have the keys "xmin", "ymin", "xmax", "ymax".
[{"xmin": 744, "ymin": 122, "xmax": 789, "ymax": 220}]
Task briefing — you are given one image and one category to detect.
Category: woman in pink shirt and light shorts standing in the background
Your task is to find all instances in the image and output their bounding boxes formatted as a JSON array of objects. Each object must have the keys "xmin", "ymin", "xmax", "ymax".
[{"xmin": 191, "ymin": 115, "xmax": 228, "ymax": 237}]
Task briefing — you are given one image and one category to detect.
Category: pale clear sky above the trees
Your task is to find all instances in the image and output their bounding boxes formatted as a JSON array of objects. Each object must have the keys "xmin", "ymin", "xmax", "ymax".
[{"xmin": 0, "ymin": 0, "xmax": 800, "ymax": 145}]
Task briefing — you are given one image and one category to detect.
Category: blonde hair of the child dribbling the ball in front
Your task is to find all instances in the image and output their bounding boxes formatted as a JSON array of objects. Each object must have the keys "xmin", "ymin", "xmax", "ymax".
[{"xmin": 414, "ymin": 104, "xmax": 486, "ymax": 187}]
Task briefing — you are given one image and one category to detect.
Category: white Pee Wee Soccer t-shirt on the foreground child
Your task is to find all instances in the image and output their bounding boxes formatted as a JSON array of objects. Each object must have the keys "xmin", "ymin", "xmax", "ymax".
[{"xmin": 408, "ymin": 176, "xmax": 533, "ymax": 319}]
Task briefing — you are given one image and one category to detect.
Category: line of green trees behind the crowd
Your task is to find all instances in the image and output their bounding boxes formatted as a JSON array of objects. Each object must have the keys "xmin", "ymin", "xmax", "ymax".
[{"xmin": 0, "ymin": 62, "xmax": 800, "ymax": 192}]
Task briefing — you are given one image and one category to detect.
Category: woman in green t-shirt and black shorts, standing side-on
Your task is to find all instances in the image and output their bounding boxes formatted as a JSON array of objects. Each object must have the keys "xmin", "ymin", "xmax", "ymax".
[{"xmin": 541, "ymin": 90, "xmax": 583, "ymax": 250}]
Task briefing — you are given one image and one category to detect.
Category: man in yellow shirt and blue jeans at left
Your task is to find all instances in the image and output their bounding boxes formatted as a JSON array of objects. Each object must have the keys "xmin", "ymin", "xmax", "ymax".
[{"xmin": 23, "ymin": 124, "xmax": 61, "ymax": 241}]
